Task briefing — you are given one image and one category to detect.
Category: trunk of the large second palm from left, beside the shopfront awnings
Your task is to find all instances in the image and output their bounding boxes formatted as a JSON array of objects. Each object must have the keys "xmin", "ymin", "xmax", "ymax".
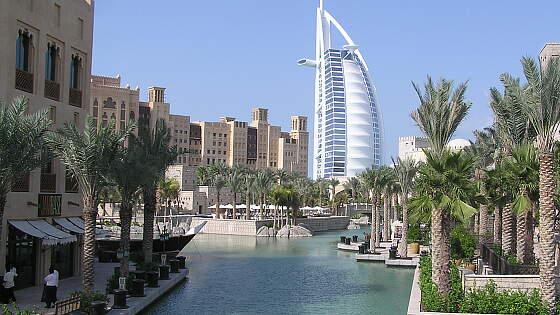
[{"xmin": 82, "ymin": 194, "xmax": 97, "ymax": 293}]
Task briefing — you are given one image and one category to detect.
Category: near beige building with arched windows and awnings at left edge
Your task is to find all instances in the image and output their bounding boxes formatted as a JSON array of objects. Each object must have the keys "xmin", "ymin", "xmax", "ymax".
[{"xmin": 0, "ymin": 0, "xmax": 94, "ymax": 289}]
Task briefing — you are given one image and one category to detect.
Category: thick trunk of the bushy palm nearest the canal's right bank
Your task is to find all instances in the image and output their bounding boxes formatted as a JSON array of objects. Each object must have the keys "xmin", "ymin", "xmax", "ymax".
[{"xmin": 432, "ymin": 208, "xmax": 451, "ymax": 295}]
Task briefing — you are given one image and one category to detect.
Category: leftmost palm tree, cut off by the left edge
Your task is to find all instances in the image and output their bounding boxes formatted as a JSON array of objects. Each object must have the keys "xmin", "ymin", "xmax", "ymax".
[{"xmin": 0, "ymin": 97, "xmax": 51, "ymax": 270}]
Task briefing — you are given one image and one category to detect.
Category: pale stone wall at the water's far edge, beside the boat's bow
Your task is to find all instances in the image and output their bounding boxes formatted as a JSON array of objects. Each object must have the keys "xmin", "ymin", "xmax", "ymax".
[{"xmin": 191, "ymin": 218, "xmax": 272, "ymax": 236}]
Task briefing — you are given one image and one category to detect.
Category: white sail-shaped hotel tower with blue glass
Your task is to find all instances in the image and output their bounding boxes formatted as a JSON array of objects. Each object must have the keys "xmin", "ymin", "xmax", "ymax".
[{"xmin": 298, "ymin": 0, "xmax": 381, "ymax": 178}]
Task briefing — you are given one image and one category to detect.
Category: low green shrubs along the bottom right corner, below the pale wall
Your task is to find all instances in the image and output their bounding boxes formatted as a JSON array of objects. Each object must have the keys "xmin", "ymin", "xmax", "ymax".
[{"xmin": 419, "ymin": 256, "xmax": 559, "ymax": 315}]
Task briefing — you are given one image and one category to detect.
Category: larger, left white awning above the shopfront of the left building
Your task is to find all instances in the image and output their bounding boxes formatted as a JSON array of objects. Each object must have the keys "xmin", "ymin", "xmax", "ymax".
[{"xmin": 9, "ymin": 220, "xmax": 76, "ymax": 245}]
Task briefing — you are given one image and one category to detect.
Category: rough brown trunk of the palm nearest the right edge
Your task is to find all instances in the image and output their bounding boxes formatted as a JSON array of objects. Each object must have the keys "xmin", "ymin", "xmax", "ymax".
[{"xmin": 539, "ymin": 152, "xmax": 556, "ymax": 313}]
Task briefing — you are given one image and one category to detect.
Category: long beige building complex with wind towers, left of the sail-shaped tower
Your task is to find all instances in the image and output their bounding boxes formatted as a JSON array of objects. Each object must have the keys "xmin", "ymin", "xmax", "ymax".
[{"xmin": 90, "ymin": 75, "xmax": 309, "ymax": 176}]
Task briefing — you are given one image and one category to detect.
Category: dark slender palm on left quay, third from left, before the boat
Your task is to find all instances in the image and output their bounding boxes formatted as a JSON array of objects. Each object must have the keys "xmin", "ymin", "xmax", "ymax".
[{"xmin": 109, "ymin": 137, "xmax": 144, "ymax": 277}]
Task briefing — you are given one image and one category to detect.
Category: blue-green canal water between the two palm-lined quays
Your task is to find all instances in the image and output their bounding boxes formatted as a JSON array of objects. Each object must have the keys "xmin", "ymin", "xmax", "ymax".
[{"xmin": 145, "ymin": 229, "xmax": 414, "ymax": 315}]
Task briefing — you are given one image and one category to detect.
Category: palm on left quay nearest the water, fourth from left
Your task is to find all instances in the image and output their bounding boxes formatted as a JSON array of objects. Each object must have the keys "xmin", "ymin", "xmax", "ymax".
[{"xmin": 138, "ymin": 119, "xmax": 177, "ymax": 262}]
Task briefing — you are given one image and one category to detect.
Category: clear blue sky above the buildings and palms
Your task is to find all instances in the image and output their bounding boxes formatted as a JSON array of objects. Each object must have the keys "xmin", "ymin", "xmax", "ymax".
[{"xmin": 93, "ymin": 0, "xmax": 560, "ymax": 168}]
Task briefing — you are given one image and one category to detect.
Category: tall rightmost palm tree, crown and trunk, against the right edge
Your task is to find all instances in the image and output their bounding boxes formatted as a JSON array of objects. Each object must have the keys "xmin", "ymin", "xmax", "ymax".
[{"xmin": 506, "ymin": 57, "xmax": 560, "ymax": 311}]
